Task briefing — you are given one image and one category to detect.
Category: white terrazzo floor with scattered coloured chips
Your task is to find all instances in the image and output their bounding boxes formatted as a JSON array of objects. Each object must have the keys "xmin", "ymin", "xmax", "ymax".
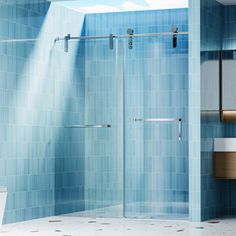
[{"xmin": 0, "ymin": 216, "xmax": 236, "ymax": 236}]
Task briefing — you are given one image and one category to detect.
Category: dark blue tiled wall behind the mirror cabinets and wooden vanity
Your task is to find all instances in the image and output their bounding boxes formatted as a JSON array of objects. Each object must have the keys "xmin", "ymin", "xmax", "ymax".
[{"xmin": 201, "ymin": 0, "xmax": 236, "ymax": 220}]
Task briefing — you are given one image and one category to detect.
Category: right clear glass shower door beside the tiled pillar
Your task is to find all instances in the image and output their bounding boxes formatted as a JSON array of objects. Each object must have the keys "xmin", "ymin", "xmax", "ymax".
[{"xmin": 124, "ymin": 36, "xmax": 188, "ymax": 218}]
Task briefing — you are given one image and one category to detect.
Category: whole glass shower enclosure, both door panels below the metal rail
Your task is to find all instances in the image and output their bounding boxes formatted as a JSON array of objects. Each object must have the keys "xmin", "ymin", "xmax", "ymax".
[{"xmin": 56, "ymin": 35, "xmax": 188, "ymax": 219}]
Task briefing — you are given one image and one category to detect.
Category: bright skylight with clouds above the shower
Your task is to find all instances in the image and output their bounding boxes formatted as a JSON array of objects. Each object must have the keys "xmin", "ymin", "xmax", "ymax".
[{"xmin": 59, "ymin": 0, "xmax": 188, "ymax": 13}]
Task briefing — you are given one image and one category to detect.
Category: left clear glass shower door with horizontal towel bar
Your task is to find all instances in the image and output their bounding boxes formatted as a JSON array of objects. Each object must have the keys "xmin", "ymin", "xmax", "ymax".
[{"xmin": 55, "ymin": 39, "xmax": 124, "ymax": 217}]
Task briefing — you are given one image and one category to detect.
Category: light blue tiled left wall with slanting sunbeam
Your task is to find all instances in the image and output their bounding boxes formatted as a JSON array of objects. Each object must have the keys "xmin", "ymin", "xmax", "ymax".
[{"xmin": 0, "ymin": 1, "xmax": 84, "ymax": 223}]
